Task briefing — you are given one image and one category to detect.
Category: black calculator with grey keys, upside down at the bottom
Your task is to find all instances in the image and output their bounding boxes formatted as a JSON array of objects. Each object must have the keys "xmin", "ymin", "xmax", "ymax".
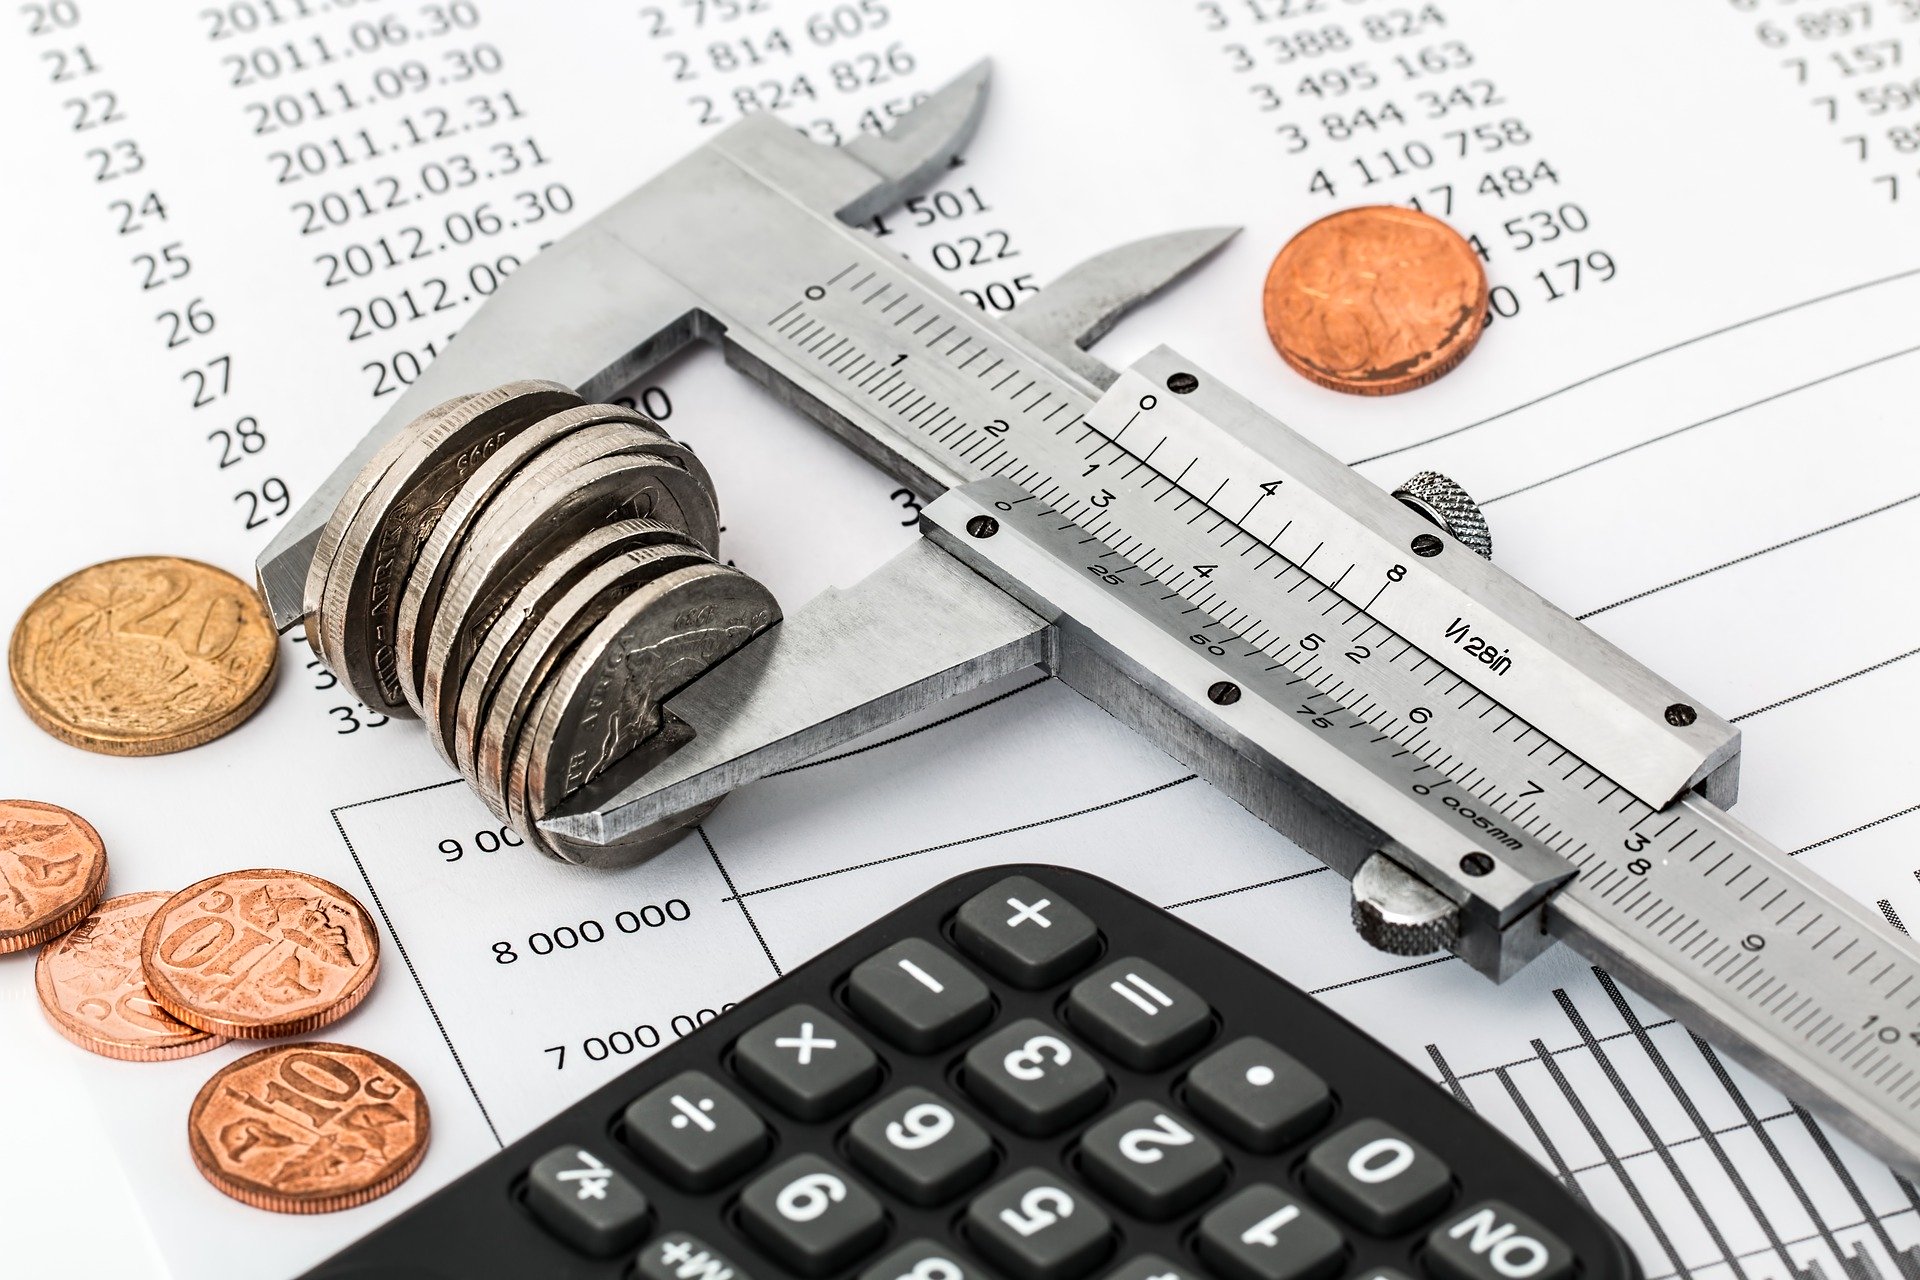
[{"xmin": 309, "ymin": 865, "xmax": 1640, "ymax": 1280}]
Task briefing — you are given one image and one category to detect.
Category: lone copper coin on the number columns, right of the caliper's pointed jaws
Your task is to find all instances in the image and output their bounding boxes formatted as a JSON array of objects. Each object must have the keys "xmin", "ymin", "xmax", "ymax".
[{"xmin": 1261, "ymin": 205, "xmax": 1486, "ymax": 395}]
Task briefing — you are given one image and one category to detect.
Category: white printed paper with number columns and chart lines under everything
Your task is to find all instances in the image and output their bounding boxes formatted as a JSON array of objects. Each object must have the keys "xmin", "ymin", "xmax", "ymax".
[{"xmin": 0, "ymin": 0, "xmax": 1920, "ymax": 1280}]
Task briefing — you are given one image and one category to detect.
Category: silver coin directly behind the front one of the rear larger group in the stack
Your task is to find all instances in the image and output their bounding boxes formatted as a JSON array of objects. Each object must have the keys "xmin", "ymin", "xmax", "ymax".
[{"xmin": 394, "ymin": 405, "xmax": 664, "ymax": 716}]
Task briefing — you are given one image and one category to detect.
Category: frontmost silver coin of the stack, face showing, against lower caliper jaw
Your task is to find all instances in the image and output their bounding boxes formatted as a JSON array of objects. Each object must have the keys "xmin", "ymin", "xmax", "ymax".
[{"xmin": 505, "ymin": 564, "xmax": 780, "ymax": 855}]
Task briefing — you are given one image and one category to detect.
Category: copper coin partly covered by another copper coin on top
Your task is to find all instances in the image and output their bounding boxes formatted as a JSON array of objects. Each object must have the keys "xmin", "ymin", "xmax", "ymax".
[{"xmin": 33, "ymin": 892, "xmax": 227, "ymax": 1063}]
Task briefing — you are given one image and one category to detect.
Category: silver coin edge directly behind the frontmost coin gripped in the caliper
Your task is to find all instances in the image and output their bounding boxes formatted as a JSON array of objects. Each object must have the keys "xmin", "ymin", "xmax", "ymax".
[{"xmin": 466, "ymin": 545, "xmax": 712, "ymax": 819}]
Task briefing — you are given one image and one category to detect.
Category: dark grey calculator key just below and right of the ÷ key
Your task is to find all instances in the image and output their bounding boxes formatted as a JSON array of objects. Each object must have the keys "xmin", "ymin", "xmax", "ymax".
[{"xmin": 739, "ymin": 1155, "xmax": 887, "ymax": 1276}]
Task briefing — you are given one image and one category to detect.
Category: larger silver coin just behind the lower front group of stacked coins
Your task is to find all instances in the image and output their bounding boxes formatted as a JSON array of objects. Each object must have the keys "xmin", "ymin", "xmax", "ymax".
[{"xmin": 420, "ymin": 441, "xmax": 720, "ymax": 754}]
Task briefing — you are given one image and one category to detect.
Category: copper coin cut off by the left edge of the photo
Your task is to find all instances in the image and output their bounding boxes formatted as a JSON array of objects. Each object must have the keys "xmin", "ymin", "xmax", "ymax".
[{"xmin": 0, "ymin": 800, "xmax": 108, "ymax": 956}]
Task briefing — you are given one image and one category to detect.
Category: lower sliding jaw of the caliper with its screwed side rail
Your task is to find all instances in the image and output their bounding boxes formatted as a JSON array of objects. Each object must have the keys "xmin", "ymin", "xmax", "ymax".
[{"xmin": 541, "ymin": 480, "xmax": 1574, "ymax": 979}]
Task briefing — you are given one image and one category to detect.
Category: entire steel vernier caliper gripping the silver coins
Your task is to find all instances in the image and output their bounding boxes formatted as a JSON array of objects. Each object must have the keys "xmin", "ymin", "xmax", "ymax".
[{"xmin": 259, "ymin": 65, "xmax": 1920, "ymax": 1173}]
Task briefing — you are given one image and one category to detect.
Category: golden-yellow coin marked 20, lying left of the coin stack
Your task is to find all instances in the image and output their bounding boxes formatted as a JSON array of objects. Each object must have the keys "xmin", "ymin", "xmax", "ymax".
[{"xmin": 8, "ymin": 557, "xmax": 280, "ymax": 756}]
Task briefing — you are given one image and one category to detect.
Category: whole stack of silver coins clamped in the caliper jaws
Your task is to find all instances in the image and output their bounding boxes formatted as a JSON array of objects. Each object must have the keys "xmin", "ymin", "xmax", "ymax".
[{"xmin": 305, "ymin": 380, "xmax": 780, "ymax": 865}]
